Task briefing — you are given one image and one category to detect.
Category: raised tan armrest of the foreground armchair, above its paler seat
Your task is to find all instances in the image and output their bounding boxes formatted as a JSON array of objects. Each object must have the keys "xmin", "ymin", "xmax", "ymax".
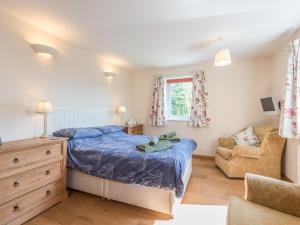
[{"xmin": 245, "ymin": 173, "xmax": 300, "ymax": 217}]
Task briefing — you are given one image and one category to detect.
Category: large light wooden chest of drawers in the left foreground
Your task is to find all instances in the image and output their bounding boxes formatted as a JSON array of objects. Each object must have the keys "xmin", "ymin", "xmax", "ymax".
[{"xmin": 0, "ymin": 138, "xmax": 68, "ymax": 225}]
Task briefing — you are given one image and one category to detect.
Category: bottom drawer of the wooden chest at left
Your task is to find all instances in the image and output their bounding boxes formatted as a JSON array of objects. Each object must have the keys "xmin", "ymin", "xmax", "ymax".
[{"xmin": 0, "ymin": 181, "xmax": 62, "ymax": 224}]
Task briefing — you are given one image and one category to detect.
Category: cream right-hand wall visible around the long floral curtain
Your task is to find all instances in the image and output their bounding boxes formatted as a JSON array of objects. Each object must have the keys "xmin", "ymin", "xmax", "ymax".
[{"xmin": 272, "ymin": 30, "xmax": 300, "ymax": 183}]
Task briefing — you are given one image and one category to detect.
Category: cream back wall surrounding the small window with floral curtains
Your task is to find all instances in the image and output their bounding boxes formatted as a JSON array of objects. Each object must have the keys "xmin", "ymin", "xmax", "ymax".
[{"xmin": 132, "ymin": 58, "xmax": 272, "ymax": 156}]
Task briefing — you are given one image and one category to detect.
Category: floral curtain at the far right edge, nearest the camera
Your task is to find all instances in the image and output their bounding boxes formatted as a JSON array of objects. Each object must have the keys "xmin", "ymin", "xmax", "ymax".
[{"xmin": 279, "ymin": 39, "xmax": 300, "ymax": 138}]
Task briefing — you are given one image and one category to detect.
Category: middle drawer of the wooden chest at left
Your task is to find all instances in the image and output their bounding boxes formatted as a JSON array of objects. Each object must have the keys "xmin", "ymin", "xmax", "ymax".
[{"xmin": 0, "ymin": 162, "xmax": 62, "ymax": 204}]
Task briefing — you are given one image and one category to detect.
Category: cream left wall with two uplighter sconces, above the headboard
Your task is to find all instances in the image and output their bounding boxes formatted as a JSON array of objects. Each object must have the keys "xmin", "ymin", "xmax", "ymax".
[{"xmin": 0, "ymin": 11, "xmax": 131, "ymax": 141}]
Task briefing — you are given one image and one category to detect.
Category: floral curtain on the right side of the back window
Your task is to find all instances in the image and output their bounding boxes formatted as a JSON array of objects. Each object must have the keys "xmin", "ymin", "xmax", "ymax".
[{"xmin": 190, "ymin": 71, "xmax": 210, "ymax": 127}]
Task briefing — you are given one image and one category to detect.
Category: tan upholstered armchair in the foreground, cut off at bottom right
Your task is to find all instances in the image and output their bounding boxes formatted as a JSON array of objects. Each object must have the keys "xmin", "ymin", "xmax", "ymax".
[{"xmin": 227, "ymin": 174, "xmax": 300, "ymax": 225}]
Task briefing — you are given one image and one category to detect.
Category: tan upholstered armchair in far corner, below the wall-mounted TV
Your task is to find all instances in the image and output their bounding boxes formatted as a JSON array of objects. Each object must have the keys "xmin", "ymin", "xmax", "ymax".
[{"xmin": 215, "ymin": 125, "xmax": 286, "ymax": 179}]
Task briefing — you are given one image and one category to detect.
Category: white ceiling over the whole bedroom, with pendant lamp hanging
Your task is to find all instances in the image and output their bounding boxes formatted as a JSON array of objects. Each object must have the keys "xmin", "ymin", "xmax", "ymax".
[{"xmin": 0, "ymin": 0, "xmax": 300, "ymax": 68}]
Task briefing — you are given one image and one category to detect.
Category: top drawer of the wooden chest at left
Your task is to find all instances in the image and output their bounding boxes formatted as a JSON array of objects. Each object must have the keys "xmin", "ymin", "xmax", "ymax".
[{"xmin": 0, "ymin": 144, "xmax": 62, "ymax": 172}]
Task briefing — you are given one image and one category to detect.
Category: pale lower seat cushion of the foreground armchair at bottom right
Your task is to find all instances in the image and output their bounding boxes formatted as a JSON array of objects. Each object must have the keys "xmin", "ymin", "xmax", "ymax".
[{"xmin": 227, "ymin": 197, "xmax": 300, "ymax": 225}]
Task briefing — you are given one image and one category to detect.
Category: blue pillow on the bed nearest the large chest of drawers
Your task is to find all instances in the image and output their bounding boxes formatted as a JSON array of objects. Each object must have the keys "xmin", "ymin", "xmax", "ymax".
[{"xmin": 53, "ymin": 127, "xmax": 103, "ymax": 139}]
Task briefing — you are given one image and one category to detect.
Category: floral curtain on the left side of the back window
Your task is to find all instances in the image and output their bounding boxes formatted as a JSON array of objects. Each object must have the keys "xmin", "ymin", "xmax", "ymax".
[{"xmin": 150, "ymin": 76, "xmax": 165, "ymax": 126}]
